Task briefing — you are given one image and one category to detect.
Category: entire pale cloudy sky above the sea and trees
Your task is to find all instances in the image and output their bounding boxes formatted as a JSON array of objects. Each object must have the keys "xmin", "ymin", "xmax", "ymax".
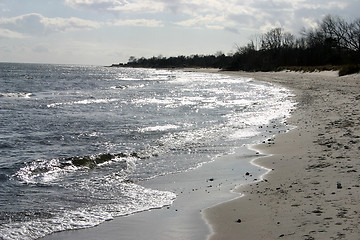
[{"xmin": 0, "ymin": 0, "xmax": 360, "ymax": 65}]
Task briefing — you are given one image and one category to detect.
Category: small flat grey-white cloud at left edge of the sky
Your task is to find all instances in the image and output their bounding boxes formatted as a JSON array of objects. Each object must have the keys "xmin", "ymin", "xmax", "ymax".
[{"xmin": 0, "ymin": 13, "xmax": 101, "ymax": 36}]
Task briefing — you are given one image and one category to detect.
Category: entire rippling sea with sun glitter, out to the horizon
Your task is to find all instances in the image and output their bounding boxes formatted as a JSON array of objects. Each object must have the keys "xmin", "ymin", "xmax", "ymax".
[{"xmin": 0, "ymin": 63, "xmax": 294, "ymax": 239}]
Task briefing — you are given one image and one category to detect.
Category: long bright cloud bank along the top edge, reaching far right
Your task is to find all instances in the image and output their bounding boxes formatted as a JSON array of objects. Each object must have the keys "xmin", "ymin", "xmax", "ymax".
[{"xmin": 64, "ymin": 0, "xmax": 349, "ymax": 33}]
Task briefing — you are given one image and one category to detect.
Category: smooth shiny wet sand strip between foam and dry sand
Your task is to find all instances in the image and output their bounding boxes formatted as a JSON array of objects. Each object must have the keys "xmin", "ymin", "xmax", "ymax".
[{"xmin": 41, "ymin": 69, "xmax": 288, "ymax": 240}]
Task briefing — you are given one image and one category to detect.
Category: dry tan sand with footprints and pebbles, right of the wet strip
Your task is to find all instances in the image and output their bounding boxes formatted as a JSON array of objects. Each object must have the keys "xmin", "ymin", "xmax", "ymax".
[{"xmin": 205, "ymin": 72, "xmax": 360, "ymax": 240}]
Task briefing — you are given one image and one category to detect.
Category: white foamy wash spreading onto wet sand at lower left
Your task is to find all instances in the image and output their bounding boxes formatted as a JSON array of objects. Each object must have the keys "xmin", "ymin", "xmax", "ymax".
[{"xmin": 0, "ymin": 182, "xmax": 176, "ymax": 240}]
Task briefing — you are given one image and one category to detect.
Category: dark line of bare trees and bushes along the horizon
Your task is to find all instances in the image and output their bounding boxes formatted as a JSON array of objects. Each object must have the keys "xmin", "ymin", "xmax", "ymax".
[{"xmin": 113, "ymin": 15, "xmax": 360, "ymax": 74}]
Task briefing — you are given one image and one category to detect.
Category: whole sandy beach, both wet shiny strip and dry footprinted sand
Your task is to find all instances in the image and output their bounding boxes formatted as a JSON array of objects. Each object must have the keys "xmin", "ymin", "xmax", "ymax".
[{"xmin": 39, "ymin": 69, "xmax": 360, "ymax": 240}]
